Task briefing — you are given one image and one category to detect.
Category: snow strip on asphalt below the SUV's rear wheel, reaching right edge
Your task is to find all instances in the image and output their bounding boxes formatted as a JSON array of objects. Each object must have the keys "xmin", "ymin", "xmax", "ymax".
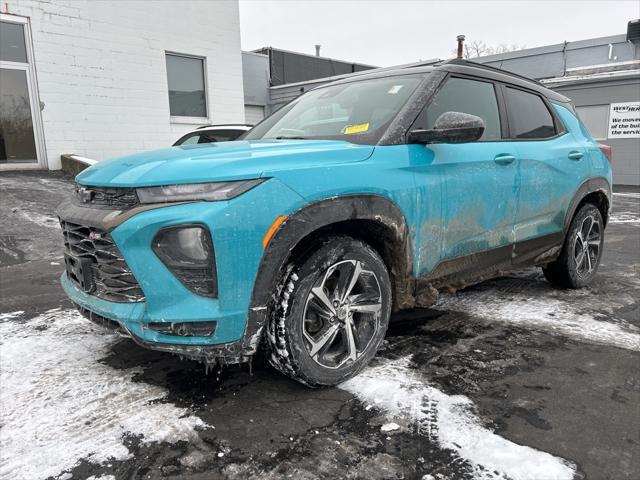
[{"xmin": 435, "ymin": 289, "xmax": 640, "ymax": 351}]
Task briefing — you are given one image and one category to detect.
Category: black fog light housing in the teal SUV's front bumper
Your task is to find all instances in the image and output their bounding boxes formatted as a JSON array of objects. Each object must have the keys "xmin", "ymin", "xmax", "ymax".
[{"xmin": 152, "ymin": 225, "xmax": 218, "ymax": 298}]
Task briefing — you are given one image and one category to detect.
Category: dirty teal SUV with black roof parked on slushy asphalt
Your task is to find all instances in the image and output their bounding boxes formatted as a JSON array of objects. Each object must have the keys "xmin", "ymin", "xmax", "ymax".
[{"xmin": 58, "ymin": 61, "xmax": 611, "ymax": 386}]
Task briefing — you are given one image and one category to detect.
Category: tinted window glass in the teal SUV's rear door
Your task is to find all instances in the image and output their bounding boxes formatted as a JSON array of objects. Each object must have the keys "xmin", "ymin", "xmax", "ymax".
[{"xmin": 506, "ymin": 87, "xmax": 556, "ymax": 139}]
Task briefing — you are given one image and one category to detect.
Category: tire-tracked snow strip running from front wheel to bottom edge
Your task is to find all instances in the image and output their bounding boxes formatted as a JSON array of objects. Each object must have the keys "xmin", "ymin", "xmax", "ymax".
[{"xmin": 340, "ymin": 357, "xmax": 575, "ymax": 480}]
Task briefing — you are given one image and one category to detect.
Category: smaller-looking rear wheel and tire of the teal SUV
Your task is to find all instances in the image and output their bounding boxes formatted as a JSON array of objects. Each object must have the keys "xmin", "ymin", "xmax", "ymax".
[{"xmin": 542, "ymin": 203, "xmax": 604, "ymax": 288}]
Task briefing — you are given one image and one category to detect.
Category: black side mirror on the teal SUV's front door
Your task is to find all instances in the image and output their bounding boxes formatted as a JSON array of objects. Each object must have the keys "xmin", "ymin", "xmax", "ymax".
[{"xmin": 408, "ymin": 112, "xmax": 484, "ymax": 143}]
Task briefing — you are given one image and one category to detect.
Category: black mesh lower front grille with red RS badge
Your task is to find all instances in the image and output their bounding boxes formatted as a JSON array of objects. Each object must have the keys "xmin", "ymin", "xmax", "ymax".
[{"xmin": 60, "ymin": 220, "xmax": 144, "ymax": 302}]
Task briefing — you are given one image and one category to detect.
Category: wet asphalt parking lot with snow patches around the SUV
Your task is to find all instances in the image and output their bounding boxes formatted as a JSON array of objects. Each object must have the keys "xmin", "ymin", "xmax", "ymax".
[{"xmin": 0, "ymin": 172, "xmax": 640, "ymax": 480}]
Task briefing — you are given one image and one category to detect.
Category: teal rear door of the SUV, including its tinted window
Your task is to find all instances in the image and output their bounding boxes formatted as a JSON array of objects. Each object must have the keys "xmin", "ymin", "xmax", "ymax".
[{"xmin": 503, "ymin": 86, "xmax": 589, "ymax": 253}]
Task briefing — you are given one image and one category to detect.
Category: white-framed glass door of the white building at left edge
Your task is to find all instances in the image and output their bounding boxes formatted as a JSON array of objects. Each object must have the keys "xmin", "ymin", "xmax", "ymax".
[{"xmin": 0, "ymin": 15, "xmax": 44, "ymax": 169}]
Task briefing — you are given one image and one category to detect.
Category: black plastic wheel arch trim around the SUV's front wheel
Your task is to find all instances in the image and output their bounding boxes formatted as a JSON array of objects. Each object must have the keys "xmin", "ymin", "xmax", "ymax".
[{"xmin": 243, "ymin": 194, "xmax": 413, "ymax": 353}]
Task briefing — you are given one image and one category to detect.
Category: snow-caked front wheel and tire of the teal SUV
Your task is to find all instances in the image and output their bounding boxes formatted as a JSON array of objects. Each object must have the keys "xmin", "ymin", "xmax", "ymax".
[{"xmin": 266, "ymin": 236, "xmax": 391, "ymax": 387}]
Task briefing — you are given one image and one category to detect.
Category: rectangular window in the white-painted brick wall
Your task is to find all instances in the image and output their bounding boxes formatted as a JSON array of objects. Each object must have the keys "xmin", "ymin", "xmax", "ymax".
[{"xmin": 166, "ymin": 53, "xmax": 207, "ymax": 118}]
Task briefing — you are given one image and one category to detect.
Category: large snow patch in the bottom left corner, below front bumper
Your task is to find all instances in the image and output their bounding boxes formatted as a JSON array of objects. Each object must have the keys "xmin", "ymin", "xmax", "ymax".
[{"xmin": 0, "ymin": 309, "xmax": 204, "ymax": 480}]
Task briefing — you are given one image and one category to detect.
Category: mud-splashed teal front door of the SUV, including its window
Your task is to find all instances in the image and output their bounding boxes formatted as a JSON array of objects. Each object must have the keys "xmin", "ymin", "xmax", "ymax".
[{"xmin": 412, "ymin": 76, "xmax": 518, "ymax": 273}]
